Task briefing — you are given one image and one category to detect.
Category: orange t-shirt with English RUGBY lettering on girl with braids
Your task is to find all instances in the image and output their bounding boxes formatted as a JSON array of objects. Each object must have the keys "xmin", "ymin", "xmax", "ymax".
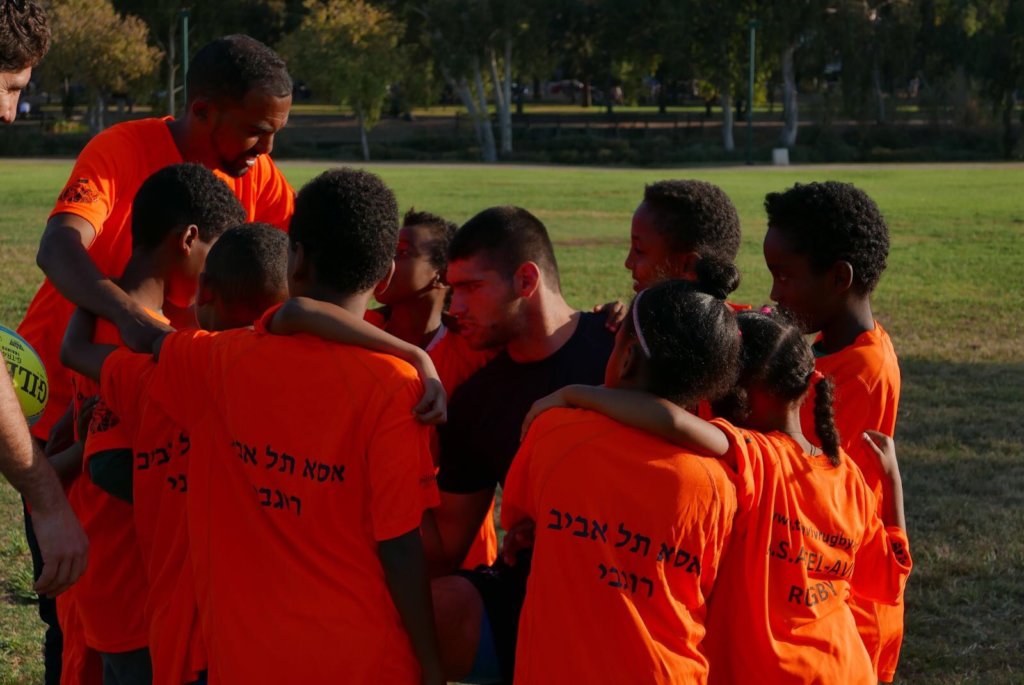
[{"xmin": 705, "ymin": 419, "xmax": 911, "ymax": 685}]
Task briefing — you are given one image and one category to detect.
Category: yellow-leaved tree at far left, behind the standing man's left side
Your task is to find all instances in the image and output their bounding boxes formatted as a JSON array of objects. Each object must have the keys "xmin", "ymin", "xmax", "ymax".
[{"xmin": 45, "ymin": 0, "xmax": 161, "ymax": 132}]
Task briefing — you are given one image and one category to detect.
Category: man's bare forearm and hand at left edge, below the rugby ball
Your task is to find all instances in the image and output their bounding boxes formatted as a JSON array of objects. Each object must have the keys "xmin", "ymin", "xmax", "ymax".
[{"xmin": 0, "ymin": 366, "xmax": 89, "ymax": 596}]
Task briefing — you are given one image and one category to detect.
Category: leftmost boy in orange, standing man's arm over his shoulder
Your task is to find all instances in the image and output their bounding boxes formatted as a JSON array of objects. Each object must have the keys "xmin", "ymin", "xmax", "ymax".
[{"xmin": 57, "ymin": 164, "xmax": 245, "ymax": 683}]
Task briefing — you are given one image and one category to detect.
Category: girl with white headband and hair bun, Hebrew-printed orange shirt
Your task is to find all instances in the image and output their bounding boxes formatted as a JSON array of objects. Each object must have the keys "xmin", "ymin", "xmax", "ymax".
[{"xmin": 502, "ymin": 281, "xmax": 739, "ymax": 685}]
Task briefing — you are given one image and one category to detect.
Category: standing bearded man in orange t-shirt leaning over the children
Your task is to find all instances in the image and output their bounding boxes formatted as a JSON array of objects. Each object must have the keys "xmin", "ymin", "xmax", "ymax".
[{"xmin": 18, "ymin": 36, "xmax": 294, "ymax": 441}]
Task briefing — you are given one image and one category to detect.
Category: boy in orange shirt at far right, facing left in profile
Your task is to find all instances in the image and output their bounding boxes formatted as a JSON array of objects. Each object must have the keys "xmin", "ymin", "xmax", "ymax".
[{"xmin": 764, "ymin": 181, "xmax": 903, "ymax": 682}]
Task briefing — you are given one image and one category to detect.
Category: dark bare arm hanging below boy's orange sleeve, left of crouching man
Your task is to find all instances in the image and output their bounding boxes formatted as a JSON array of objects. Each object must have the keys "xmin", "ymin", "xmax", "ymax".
[{"xmin": 377, "ymin": 529, "xmax": 444, "ymax": 684}]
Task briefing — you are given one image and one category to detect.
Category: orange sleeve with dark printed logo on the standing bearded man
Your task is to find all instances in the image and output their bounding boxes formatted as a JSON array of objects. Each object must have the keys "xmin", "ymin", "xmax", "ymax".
[{"xmin": 50, "ymin": 129, "xmax": 124, "ymax": 236}]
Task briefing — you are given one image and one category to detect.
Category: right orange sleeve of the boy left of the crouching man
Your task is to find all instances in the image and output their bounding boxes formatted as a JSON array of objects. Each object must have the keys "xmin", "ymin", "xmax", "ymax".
[{"xmin": 367, "ymin": 379, "xmax": 439, "ymax": 541}]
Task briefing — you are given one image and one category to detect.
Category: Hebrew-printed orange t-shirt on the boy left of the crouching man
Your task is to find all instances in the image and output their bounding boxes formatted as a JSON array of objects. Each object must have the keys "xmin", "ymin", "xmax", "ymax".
[{"xmin": 150, "ymin": 308, "xmax": 438, "ymax": 685}]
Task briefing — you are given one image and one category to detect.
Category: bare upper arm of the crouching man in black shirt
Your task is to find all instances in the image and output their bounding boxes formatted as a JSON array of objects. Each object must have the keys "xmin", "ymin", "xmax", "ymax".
[{"xmin": 421, "ymin": 488, "xmax": 495, "ymax": 577}]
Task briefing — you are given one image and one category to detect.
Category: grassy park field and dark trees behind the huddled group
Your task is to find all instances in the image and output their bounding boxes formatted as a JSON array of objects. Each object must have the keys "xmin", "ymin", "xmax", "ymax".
[{"xmin": 0, "ymin": 0, "xmax": 1024, "ymax": 684}]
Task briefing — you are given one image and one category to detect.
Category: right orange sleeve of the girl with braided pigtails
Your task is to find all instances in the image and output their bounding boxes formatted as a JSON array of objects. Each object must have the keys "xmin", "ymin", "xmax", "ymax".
[{"xmin": 850, "ymin": 493, "xmax": 913, "ymax": 604}]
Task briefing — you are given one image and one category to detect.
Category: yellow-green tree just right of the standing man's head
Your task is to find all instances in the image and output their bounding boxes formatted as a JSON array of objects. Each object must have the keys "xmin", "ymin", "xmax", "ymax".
[{"xmin": 281, "ymin": 0, "xmax": 406, "ymax": 161}]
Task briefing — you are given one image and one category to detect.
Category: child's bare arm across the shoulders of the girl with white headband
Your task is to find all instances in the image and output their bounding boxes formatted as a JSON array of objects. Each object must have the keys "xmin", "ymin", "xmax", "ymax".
[{"xmin": 522, "ymin": 385, "xmax": 729, "ymax": 457}]
